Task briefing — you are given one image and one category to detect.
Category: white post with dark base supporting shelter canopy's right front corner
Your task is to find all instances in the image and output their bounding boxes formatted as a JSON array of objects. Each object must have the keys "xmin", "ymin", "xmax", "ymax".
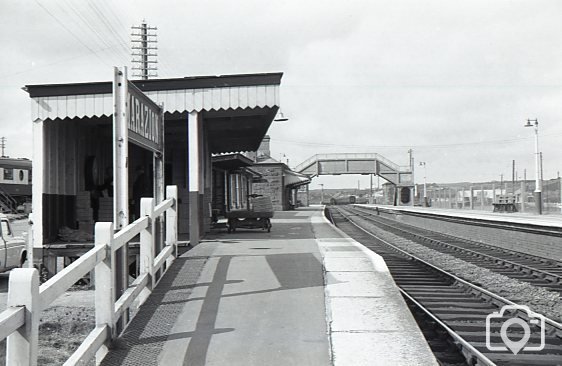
[{"xmin": 187, "ymin": 111, "xmax": 201, "ymax": 246}]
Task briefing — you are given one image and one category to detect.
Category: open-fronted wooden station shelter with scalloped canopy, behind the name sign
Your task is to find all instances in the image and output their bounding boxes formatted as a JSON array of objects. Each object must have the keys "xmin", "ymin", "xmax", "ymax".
[{"xmin": 25, "ymin": 73, "xmax": 282, "ymax": 272}]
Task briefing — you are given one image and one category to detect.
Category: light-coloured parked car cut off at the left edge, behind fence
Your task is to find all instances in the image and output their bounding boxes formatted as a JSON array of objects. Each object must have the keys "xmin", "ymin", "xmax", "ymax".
[{"xmin": 0, "ymin": 214, "xmax": 27, "ymax": 272}]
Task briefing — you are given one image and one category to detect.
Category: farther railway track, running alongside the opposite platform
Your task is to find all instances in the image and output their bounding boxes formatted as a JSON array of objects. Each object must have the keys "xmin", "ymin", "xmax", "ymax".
[{"xmin": 346, "ymin": 207, "xmax": 562, "ymax": 293}]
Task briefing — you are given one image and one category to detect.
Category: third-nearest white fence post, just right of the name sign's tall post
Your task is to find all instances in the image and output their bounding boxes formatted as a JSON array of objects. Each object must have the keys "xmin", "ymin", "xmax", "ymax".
[{"xmin": 139, "ymin": 197, "xmax": 156, "ymax": 304}]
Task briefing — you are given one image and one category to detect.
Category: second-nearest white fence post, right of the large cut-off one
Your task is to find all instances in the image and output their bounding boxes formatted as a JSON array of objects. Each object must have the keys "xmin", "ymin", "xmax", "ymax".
[{"xmin": 94, "ymin": 222, "xmax": 116, "ymax": 364}]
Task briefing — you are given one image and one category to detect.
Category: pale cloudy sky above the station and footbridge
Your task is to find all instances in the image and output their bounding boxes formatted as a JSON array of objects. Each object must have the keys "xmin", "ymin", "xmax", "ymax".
[{"xmin": 0, "ymin": 0, "xmax": 562, "ymax": 188}]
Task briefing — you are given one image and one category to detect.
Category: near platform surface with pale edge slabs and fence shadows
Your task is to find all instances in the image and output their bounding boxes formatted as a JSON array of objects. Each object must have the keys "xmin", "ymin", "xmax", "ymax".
[{"xmin": 98, "ymin": 206, "xmax": 437, "ymax": 366}]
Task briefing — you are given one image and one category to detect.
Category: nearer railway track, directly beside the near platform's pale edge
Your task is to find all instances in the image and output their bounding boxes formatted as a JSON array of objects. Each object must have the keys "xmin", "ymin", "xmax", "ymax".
[{"xmin": 331, "ymin": 208, "xmax": 562, "ymax": 366}]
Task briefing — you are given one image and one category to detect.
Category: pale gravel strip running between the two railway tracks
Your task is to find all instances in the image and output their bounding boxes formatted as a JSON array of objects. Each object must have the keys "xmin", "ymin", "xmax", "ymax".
[{"xmin": 354, "ymin": 214, "xmax": 562, "ymax": 322}]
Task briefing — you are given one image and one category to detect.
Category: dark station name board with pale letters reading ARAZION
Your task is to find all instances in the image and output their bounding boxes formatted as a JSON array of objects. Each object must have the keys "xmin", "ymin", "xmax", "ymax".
[{"xmin": 127, "ymin": 81, "xmax": 164, "ymax": 153}]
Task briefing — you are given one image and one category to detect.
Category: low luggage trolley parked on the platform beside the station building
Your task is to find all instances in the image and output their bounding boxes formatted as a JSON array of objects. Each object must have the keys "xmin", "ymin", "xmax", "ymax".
[{"xmin": 225, "ymin": 195, "xmax": 273, "ymax": 233}]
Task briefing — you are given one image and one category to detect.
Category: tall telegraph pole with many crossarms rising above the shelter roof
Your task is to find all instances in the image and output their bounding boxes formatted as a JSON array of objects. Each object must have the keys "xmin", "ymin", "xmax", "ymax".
[{"xmin": 131, "ymin": 20, "xmax": 158, "ymax": 80}]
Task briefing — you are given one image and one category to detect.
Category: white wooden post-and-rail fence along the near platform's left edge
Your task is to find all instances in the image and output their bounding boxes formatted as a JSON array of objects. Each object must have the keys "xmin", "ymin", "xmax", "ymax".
[{"xmin": 0, "ymin": 186, "xmax": 178, "ymax": 366}]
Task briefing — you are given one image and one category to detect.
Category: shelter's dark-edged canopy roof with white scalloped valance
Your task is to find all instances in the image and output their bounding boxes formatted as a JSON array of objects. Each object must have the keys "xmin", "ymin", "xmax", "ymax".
[{"xmin": 24, "ymin": 73, "xmax": 283, "ymax": 153}]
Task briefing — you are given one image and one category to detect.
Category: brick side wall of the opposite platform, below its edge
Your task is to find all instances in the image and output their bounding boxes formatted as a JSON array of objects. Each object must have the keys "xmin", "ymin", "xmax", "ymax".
[{"xmin": 372, "ymin": 209, "xmax": 562, "ymax": 261}]
